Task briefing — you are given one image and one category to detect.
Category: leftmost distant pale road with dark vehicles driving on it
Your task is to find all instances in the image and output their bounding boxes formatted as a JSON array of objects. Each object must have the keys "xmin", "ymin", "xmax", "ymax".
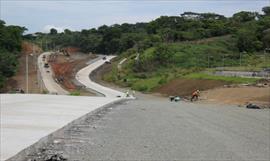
[{"xmin": 38, "ymin": 52, "xmax": 69, "ymax": 95}]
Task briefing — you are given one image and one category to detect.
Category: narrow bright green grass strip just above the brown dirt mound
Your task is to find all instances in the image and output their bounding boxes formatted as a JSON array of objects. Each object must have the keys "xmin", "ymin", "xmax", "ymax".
[{"xmin": 184, "ymin": 73, "xmax": 259, "ymax": 84}]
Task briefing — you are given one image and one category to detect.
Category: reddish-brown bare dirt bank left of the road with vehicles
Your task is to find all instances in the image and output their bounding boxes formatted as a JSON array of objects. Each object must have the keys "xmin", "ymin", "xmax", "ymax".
[{"xmin": 4, "ymin": 42, "xmax": 42, "ymax": 93}]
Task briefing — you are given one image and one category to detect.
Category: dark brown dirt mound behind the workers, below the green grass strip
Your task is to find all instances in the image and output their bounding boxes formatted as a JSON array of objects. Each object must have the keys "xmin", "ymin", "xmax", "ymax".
[{"xmin": 155, "ymin": 79, "xmax": 227, "ymax": 96}]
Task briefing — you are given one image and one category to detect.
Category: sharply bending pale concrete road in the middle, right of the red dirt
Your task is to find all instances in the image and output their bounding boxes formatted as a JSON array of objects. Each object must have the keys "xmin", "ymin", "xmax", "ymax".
[{"xmin": 76, "ymin": 56, "xmax": 125, "ymax": 98}]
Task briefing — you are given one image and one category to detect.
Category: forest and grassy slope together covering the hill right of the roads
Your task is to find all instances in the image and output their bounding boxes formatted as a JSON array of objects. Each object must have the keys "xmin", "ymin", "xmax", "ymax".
[{"xmin": 21, "ymin": 6, "xmax": 270, "ymax": 92}]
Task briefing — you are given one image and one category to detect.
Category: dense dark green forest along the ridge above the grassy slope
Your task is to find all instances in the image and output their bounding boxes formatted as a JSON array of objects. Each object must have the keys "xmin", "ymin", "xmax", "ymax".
[{"xmin": 28, "ymin": 7, "xmax": 270, "ymax": 54}]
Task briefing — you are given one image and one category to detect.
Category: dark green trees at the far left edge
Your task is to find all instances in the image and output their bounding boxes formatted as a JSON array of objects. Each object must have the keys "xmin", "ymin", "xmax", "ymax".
[{"xmin": 0, "ymin": 20, "xmax": 26, "ymax": 89}]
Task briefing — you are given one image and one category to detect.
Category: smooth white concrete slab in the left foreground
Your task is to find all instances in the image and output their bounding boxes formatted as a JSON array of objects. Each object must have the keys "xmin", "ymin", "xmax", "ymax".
[{"xmin": 0, "ymin": 94, "xmax": 117, "ymax": 160}]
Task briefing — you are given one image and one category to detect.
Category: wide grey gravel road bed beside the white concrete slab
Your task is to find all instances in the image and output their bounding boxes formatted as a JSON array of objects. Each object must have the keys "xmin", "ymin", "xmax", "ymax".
[{"xmin": 7, "ymin": 97, "xmax": 270, "ymax": 161}]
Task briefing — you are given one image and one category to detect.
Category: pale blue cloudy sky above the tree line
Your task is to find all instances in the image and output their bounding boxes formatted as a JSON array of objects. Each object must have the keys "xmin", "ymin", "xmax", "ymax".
[{"xmin": 0, "ymin": 0, "xmax": 270, "ymax": 33}]
